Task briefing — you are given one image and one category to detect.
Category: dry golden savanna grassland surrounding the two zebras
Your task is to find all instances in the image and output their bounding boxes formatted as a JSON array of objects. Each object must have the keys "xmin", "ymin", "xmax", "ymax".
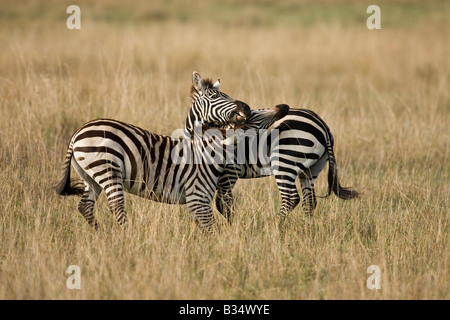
[{"xmin": 0, "ymin": 0, "xmax": 450, "ymax": 299}]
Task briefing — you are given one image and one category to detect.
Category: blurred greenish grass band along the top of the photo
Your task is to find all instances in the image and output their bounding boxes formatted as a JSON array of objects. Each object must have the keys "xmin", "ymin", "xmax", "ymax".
[{"xmin": 0, "ymin": 0, "xmax": 449, "ymax": 28}]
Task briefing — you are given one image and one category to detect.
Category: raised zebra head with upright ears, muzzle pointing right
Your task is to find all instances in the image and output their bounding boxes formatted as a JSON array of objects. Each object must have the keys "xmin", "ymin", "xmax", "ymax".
[{"xmin": 185, "ymin": 71, "xmax": 251, "ymax": 134}]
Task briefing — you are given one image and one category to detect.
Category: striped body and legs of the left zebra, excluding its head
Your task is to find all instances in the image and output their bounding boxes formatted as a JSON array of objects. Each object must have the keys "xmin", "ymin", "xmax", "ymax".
[{"xmin": 55, "ymin": 119, "xmax": 223, "ymax": 229}]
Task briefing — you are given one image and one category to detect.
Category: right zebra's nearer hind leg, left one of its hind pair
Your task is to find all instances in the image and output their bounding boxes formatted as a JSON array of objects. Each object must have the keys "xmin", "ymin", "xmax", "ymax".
[{"xmin": 275, "ymin": 175, "xmax": 300, "ymax": 223}]
